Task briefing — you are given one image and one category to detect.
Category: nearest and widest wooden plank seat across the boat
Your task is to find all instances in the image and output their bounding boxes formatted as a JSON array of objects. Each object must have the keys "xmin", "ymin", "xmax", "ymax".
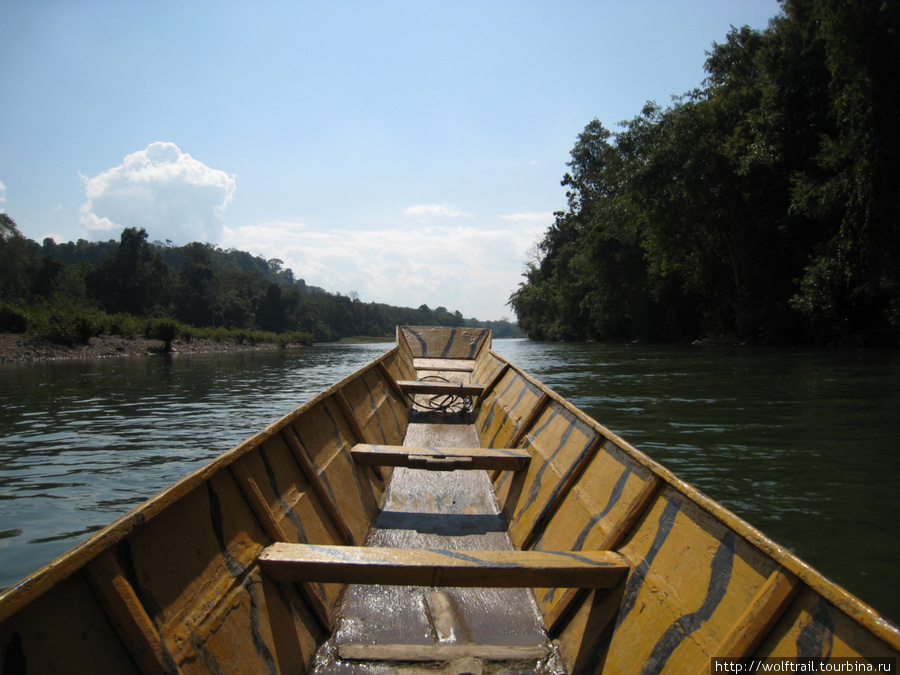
[{"xmin": 259, "ymin": 542, "xmax": 629, "ymax": 588}]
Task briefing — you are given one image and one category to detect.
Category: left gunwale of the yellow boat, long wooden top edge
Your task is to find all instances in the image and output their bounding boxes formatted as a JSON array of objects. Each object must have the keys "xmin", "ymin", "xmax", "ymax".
[{"xmin": 0, "ymin": 345, "xmax": 400, "ymax": 623}]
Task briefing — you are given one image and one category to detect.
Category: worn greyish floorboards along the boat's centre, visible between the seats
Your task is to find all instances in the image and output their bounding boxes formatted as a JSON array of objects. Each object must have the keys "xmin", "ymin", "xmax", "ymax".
[{"xmin": 314, "ymin": 372, "xmax": 563, "ymax": 675}]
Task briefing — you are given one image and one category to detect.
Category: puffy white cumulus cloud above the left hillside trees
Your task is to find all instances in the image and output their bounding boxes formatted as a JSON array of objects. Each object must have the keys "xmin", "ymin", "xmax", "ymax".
[{"xmin": 81, "ymin": 142, "xmax": 235, "ymax": 244}]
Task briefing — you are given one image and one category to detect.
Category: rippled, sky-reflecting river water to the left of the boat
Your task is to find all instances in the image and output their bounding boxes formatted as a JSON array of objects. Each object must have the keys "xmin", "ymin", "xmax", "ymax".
[{"xmin": 0, "ymin": 343, "xmax": 392, "ymax": 587}]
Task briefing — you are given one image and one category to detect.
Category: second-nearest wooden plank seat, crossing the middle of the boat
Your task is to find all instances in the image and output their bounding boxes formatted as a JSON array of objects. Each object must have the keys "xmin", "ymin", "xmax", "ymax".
[{"xmin": 351, "ymin": 443, "xmax": 531, "ymax": 471}]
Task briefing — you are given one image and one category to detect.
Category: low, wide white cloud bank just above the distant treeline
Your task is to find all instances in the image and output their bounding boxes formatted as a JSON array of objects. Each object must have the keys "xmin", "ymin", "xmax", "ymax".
[{"xmin": 222, "ymin": 218, "xmax": 544, "ymax": 319}]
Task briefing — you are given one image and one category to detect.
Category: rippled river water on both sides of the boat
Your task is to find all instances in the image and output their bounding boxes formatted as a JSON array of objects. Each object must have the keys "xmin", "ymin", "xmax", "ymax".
[{"xmin": 0, "ymin": 340, "xmax": 900, "ymax": 621}]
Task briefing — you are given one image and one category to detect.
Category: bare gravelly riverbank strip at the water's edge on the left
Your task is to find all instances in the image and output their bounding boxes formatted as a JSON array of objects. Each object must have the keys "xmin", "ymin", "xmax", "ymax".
[{"xmin": 0, "ymin": 333, "xmax": 302, "ymax": 363}]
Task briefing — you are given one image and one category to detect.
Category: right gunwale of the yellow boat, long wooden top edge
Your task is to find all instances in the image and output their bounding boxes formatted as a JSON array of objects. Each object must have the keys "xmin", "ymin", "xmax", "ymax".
[{"xmin": 490, "ymin": 350, "xmax": 900, "ymax": 650}]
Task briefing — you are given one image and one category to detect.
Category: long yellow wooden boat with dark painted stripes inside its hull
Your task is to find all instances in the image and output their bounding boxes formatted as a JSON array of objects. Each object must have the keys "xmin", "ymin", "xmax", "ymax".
[{"xmin": 0, "ymin": 327, "xmax": 900, "ymax": 674}]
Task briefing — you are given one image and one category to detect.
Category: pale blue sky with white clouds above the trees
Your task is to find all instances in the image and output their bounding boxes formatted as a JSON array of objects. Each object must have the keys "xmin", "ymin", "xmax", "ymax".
[{"xmin": 0, "ymin": 0, "xmax": 780, "ymax": 320}]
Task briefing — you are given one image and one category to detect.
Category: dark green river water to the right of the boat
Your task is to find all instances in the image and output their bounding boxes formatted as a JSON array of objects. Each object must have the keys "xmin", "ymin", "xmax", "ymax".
[{"xmin": 495, "ymin": 340, "xmax": 900, "ymax": 622}]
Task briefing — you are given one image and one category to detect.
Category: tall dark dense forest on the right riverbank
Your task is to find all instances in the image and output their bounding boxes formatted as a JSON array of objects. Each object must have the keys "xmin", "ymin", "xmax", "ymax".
[{"xmin": 510, "ymin": 0, "xmax": 900, "ymax": 345}]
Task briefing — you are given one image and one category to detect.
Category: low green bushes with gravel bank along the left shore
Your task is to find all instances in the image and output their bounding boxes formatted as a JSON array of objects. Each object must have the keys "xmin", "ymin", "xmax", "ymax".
[{"xmin": 0, "ymin": 306, "xmax": 313, "ymax": 362}]
